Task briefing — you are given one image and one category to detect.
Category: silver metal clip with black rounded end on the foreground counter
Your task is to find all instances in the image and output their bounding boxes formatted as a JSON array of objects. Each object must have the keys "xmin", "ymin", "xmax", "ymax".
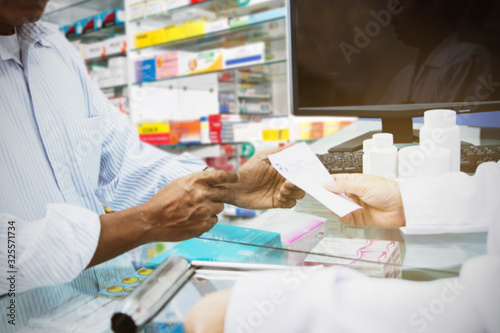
[{"xmin": 111, "ymin": 256, "xmax": 297, "ymax": 333}]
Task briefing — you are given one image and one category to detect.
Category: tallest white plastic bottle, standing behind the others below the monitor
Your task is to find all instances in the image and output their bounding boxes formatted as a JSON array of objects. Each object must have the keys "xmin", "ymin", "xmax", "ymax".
[{"xmin": 420, "ymin": 109, "xmax": 460, "ymax": 171}]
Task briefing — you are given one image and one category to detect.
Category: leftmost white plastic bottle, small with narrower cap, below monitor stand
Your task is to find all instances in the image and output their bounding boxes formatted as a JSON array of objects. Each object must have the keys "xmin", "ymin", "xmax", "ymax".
[{"xmin": 368, "ymin": 133, "xmax": 398, "ymax": 179}]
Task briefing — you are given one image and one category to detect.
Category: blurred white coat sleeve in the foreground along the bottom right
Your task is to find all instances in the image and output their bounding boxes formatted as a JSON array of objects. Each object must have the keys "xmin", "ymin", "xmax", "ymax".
[{"xmin": 224, "ymin": 256, "xmax": 500, "ymax": 333}]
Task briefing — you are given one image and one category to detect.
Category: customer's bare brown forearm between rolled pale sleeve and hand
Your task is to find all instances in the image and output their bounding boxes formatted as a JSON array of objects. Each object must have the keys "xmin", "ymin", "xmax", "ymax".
[{"xmin": 87, "ymin": 205, "xmax": 152, "ymax": 268}]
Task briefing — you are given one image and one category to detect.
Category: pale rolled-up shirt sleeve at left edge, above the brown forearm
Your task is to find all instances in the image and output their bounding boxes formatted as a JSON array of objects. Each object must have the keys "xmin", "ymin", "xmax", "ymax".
[{"xmin": 0, "ymin": 204, "xmax": 101, "ymax": 295}]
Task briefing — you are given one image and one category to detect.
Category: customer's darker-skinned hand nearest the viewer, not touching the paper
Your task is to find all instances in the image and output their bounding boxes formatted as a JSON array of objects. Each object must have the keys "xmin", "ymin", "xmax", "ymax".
[{"xmin": 142, "ymin": 170, "xmax": 238, "ymax": 242}]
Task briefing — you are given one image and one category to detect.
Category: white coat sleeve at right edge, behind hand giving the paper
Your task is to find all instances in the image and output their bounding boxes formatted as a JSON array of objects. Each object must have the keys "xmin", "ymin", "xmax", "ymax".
[{"xmin": 399, "ymin": 162, "xmax": 500, "ymax": 234}]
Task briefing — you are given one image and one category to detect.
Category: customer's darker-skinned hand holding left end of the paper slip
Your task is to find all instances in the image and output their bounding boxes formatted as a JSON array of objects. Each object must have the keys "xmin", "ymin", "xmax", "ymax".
[{"xmin": 224, "ymin": 145, "xmax": 305, "ymax": 209}]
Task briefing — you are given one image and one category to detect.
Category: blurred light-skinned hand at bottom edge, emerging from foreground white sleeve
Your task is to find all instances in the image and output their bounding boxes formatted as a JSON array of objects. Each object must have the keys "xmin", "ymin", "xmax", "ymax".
[{"xmin": 184, "ymin": 289, "xmax": 231, "ymax": 333}]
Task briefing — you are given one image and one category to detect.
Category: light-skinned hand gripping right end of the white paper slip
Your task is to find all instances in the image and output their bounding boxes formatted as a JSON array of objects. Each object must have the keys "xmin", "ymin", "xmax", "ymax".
[{"xmin": 324, "ymin": 174, "xmax": 405, "ymax": 228}]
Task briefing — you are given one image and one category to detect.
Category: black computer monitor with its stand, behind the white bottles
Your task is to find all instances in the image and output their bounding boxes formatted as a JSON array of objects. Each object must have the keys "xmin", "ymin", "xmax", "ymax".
[{"xmin": 288, "ymin": 0, "xmax": 500, "ymax": 148}]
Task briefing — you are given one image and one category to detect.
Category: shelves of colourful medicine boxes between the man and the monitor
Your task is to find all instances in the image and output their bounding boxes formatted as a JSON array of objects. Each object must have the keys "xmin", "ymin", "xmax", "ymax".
[{"xmin": 125, "ymin": 0, "xmax": 288, "ymax": 145}]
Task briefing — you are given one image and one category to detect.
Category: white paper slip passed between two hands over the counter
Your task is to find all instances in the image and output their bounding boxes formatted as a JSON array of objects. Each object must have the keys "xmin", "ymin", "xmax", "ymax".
[{"xmin": 269, "ymin": 142, "xmax": 361, "ymax": 217}]
